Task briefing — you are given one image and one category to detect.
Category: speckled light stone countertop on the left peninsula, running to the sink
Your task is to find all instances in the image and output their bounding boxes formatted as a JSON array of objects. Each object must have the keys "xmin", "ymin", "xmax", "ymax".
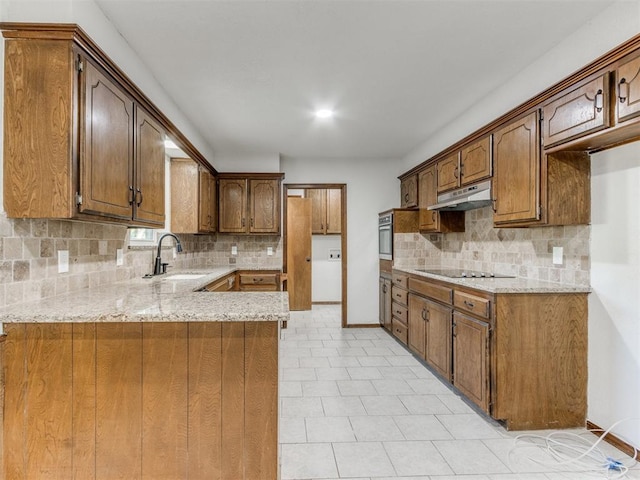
[{"xmin": 0, "ymin": 267, "xmax": 289, "ymax": 323}]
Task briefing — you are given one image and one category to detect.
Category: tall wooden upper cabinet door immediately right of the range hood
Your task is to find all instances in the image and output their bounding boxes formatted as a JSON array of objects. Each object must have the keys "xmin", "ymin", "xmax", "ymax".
[{"xmin": 493, "ymin": 111, "xmax": 540, "ymax": 224}]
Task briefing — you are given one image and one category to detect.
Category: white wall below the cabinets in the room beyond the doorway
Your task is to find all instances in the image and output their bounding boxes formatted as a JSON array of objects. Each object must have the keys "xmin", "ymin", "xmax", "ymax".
[{"xmin": 311, "ymin": 235, "xmax": 342, "ymax": 302}]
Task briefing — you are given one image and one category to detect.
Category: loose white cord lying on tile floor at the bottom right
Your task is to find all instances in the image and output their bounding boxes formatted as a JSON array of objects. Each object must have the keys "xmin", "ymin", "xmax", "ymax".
[{"xmin": 509, "ymin": 418, "xmax": 640, "ymax": 480}]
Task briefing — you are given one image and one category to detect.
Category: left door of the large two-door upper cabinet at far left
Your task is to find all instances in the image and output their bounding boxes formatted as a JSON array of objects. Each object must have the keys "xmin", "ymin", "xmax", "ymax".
[{"xmin": 79, "ymin": 58, "xmax": 135, "ymax": 220}]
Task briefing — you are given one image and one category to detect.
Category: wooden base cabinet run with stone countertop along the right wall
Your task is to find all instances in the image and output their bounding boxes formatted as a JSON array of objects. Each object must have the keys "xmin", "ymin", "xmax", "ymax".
[{"xmin": 380, "ymin": 267, "xmax": 590, "ymax": 430}]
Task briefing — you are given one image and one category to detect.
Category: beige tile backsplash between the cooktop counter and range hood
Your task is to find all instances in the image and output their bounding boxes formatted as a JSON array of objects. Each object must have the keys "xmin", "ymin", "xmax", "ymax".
[{"xmin": 394, "ymin": 207, "xmax": 591, "ymax": 286}]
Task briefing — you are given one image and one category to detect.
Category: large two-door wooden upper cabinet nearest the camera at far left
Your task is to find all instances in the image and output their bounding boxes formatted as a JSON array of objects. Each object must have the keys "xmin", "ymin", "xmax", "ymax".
[{"xmin": 3, "ymin": 30, "xmax": 164, "ymax": 227}]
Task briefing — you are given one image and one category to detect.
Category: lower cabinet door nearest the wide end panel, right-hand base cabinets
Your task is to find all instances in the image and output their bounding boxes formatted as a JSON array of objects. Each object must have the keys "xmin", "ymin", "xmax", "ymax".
[{"xmin": 453, "ymin": 312, "xmax": 489, "ymax": 412}]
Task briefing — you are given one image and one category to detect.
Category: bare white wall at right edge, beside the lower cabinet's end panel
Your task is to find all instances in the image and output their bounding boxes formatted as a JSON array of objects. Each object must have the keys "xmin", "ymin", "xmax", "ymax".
[{"xmin": 588, "ymin": 142, "xmax": 640, "ymax": 446}]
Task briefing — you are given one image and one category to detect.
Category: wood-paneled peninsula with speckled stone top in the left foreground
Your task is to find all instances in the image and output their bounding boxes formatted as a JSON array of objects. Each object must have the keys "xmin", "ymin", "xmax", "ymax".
[{"xmin": 0, "ymin": 268, "xmax": 289, "ymax": 479}]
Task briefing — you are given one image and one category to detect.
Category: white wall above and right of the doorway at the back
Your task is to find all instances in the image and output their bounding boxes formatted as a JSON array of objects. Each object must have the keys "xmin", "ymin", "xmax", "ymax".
[{"xmin": 280, "ymin": 157, "xmax": 401, "ymax": 324}]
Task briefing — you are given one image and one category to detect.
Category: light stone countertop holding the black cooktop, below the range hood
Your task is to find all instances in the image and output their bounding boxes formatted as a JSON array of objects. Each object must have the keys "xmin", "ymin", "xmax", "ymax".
[{"xmin": 393, "ymin": 267, "xmax": 591, "ymax": 293}]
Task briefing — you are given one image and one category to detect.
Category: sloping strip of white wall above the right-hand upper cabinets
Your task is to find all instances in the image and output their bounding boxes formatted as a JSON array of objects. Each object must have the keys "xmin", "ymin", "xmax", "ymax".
[{"xmin": 402, "ymin": 0, "xmax": 640, "ymax": 171}]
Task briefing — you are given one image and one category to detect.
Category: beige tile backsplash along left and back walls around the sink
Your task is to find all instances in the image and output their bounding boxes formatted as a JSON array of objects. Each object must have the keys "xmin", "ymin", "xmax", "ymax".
[{"xmin": 0, "ymin": 215, "xmax": 282, "ymax": 307}]
